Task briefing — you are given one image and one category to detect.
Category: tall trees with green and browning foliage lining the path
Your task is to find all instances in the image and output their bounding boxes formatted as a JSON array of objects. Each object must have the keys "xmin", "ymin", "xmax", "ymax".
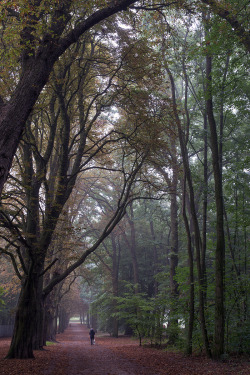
[{"xmin": 1, "ymin": 1, "xmax": 249, "ymax": 358}]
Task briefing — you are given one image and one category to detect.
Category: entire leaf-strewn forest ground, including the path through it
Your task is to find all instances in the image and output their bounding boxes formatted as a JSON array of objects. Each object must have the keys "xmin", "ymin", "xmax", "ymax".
[{"xmin": 0, "ymin": 323, "xmax": 250, "ymax": 375}]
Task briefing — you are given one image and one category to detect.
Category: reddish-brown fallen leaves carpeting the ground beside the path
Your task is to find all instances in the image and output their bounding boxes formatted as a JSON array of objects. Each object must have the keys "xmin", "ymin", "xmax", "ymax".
[{"xmin": 0, "ymin": 326, "xmax": 250, "ymax": 375}]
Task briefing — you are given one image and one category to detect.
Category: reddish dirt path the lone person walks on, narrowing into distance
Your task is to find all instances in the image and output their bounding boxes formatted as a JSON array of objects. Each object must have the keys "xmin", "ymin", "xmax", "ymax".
[{"xmin": 54, "ymin": 324, "xmax": 158, "ymax": 375}]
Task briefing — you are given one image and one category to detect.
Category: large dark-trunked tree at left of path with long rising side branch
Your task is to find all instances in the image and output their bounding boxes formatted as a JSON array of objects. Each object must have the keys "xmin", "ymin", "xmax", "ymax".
[{"xmin": 2, "ymin": 22, "xmax": 152, "ymax": 357}]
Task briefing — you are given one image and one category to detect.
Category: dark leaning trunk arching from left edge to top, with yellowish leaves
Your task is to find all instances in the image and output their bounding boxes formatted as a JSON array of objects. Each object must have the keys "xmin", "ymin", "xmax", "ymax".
[{"xmin": 0, "ymin": 0, "xmax": 139, "ymax": 198}]
